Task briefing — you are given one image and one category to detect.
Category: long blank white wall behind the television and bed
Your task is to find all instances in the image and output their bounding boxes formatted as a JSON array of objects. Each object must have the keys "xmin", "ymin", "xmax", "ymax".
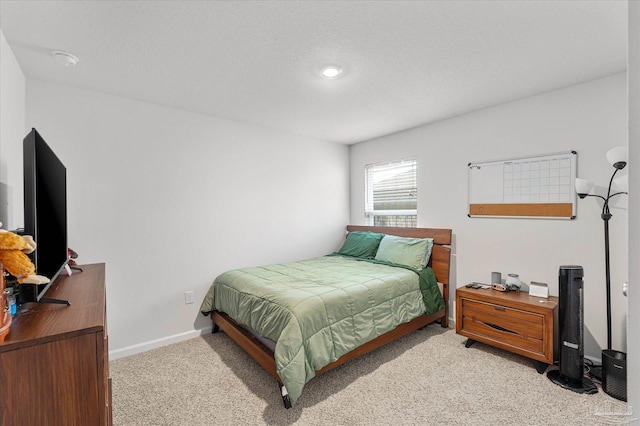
[{"xmin": 27, "ymin": 79, "xmax": 349, "ymax": 357}]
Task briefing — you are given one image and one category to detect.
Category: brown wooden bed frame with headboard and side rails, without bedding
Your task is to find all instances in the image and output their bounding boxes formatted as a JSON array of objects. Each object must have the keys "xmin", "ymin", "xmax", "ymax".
[{"xmin": 211, "ymin": 225, "xmax": 451, "ymax": 408}]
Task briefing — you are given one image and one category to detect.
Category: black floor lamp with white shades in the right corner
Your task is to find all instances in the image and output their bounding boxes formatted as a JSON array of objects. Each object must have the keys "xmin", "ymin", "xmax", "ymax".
[{"xmin": 576, "ymin": 146, "xmax": 627, "ymax": 401}]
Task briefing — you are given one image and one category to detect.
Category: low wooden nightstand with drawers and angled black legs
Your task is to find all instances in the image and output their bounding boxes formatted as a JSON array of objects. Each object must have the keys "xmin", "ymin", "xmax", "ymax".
[{"xmin": 456, "ymin": 287, "xmax": 558, "ymax": 374}]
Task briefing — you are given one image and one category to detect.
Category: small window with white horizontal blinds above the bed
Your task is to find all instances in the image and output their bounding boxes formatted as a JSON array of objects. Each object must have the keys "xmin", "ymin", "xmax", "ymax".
[{"xmin": 365, "ymin": 160, "xmax": 418, "ymax": 227}]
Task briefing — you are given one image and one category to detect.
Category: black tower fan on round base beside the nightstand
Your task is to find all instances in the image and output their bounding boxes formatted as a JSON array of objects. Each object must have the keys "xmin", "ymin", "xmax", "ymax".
[{"xmin": 547, "ymin": 265, "xmax": 598, "ymax": 394}]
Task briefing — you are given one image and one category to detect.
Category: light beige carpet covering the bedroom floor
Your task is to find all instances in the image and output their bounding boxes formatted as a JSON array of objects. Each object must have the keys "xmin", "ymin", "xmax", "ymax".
[{"xmin": 110, "ymin": 325, "xmax": 630, "ymax": 425}]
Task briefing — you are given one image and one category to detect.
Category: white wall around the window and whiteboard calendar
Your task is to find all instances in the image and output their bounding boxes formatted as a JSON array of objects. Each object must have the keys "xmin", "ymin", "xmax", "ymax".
[{"xmin": 351, "ymin": 74, "xmax": 627, "ymax": 358}]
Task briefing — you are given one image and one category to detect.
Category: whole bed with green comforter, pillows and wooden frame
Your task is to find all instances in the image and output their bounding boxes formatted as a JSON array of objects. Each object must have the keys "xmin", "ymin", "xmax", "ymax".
[{"xmin": 200, "ymin": 226, "xmax": 451, "ymax": 408}]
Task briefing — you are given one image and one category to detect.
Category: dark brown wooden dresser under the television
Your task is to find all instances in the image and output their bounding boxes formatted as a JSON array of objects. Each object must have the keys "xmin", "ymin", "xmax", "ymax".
[{"xmin": 0, "ymin": 264, "xmax": 111, "ymax": 426}]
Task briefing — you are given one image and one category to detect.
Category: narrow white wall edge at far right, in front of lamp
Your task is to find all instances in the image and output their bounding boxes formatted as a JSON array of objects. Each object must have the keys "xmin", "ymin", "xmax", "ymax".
[{"xmin": 627, "ymin": 1, "xmax": 640, "ymax": 419}]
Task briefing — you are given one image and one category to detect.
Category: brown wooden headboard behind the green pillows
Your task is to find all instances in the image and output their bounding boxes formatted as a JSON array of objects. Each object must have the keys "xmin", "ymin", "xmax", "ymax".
[{"xmin": 347, "ymin": 225, "xmax": 451, "ymax": 286}]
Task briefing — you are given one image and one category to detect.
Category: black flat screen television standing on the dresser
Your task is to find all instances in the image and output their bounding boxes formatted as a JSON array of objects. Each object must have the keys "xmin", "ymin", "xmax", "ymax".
[{"xmin": 21, "ymin": 129, "xmax": 69, "ymax": 302}]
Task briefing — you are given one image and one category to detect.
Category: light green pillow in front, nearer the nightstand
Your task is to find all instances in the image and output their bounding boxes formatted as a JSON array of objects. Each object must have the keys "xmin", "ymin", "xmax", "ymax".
[{"xmin": 375, "ymin": 235, "xmax": 433, "ymax": 269}]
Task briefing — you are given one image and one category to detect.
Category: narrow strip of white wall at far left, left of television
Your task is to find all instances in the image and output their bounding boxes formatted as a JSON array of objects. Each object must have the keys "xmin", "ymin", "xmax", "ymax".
[{"xmin": 0, "ymin": 31, "xmax": 27, "ymax": 229}]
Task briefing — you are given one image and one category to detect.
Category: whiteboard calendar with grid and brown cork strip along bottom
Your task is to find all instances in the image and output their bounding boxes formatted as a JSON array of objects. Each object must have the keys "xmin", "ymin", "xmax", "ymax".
[{"xmin": 468, "ymin": 151, "xmax": 578, "ymax": 219}]
